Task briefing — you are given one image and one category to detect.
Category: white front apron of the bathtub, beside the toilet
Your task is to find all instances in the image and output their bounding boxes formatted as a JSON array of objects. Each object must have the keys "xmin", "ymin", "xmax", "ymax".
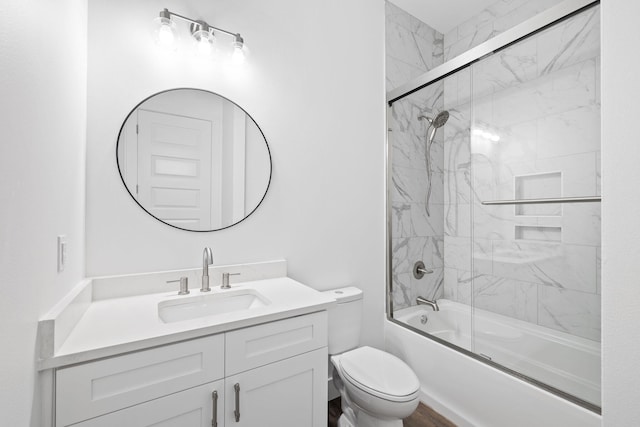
[{"xmin": 385, "ymin": 320, "xmax": 602, "ymax": 427}]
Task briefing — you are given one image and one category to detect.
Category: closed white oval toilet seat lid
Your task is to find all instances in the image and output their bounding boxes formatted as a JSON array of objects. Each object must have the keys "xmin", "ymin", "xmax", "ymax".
[{"xmin": 340, "ymin": 347, "xmax": 420, "ymax": 400}]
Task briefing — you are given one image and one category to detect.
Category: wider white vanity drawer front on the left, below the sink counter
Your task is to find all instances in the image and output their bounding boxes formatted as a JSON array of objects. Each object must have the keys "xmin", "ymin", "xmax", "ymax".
[{"xmin": 56, "ymin": 334, "xmax": 224, "ymax": 427}]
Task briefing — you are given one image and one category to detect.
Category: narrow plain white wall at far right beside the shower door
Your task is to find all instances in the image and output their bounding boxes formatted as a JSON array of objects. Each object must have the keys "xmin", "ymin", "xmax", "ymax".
[{"xmin": 602, "ymin": 1, "xmax": 640, "ymax": 427}]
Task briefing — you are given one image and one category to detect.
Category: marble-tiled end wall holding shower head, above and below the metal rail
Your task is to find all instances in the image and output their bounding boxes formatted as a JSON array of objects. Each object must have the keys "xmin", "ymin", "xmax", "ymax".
[{"xmin": 386, "ymin": 2, "xmax": 445, "ymax": 309}]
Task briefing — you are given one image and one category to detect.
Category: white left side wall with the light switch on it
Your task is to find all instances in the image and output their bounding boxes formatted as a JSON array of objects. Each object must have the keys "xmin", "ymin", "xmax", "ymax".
[{"xmin": 0, "ymin": 0, "xmax": 87, "ymax": 426}]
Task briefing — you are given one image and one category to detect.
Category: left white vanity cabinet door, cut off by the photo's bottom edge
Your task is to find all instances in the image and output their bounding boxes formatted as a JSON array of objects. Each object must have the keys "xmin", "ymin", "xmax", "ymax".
[{"xmin": 74, "ymin": 380, "xmax": 224, "ymax": 427}]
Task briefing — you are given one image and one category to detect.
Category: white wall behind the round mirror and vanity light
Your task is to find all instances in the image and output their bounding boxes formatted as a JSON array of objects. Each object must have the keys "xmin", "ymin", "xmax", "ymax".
[{"xmin": 87, "ymin": 0, "xmax": 385, "ymax": 345}]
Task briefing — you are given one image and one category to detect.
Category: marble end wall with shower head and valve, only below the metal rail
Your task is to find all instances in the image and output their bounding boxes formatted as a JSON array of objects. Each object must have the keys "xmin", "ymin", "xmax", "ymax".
[{"xmin": 389, "ymin": 84, "xmax": 445, "ymax": 309}]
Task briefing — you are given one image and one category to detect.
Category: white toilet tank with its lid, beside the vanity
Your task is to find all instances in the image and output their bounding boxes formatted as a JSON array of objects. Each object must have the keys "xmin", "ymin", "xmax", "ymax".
[{"xmin": 323, "ymin": 286, "xmax": 362, "ymax": 354}]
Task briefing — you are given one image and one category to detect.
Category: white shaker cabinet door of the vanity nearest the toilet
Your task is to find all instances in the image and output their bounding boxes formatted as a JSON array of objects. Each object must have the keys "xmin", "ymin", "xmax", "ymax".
[{"xmin": 225, "ymin": 347, "xmax": 327, "ymax": 427}]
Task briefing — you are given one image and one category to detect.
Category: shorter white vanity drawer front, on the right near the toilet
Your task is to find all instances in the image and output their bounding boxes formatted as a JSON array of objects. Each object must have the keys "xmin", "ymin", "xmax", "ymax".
[{"xmin": 225, "ymin": 311, "xmax": 327, "ymax": 376}]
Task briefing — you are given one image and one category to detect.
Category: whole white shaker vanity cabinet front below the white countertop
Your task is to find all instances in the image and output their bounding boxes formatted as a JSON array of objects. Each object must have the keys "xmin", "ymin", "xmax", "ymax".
[{"xmin": 55, "ymin": 311, "xmax": 327, "ymax": 427}]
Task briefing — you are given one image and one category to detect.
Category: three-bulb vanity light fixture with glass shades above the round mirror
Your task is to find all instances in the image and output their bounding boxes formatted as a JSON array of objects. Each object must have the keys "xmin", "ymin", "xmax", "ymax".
[{"xmin": 153, "ymin": 9, "xmax": 247, "ymax": 64}]
